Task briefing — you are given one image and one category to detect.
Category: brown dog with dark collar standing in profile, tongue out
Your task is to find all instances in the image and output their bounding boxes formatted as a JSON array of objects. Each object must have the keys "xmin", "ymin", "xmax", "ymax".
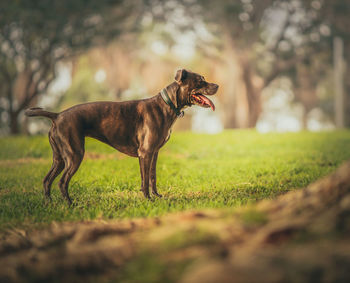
[{"xmin": 25, "ymin": 70, "xmax": 218, "ymax": 204}]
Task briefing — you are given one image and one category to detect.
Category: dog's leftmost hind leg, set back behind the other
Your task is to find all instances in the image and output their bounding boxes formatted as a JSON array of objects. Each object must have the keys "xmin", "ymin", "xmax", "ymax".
[{"xmin": 43, "ymin": 128, "xmax": 64, "ymax": 200}]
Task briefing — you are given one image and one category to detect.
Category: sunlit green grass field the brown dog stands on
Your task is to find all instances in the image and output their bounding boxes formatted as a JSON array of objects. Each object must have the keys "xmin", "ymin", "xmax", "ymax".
[{"xmin": 0, "ymin": 131, "xmax": 350, "ymax": 232}]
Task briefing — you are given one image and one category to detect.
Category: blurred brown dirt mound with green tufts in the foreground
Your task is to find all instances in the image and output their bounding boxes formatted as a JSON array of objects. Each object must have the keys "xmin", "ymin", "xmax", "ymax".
[{"xmin": 0, "ymin": 162, "xmax": 350, "ymax": 283}]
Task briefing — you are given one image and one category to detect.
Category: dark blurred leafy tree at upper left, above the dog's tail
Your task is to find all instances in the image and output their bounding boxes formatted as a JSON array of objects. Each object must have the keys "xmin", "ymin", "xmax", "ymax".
[{"xmin": 0, "ymin": 0, "xmax": 143, "ymax": 134}]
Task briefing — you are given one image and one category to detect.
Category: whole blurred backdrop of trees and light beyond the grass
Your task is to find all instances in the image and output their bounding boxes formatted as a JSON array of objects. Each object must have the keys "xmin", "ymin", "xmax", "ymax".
[{"xmin": 0, "ymin": 0, "xmax": 350, "ymax": 136}]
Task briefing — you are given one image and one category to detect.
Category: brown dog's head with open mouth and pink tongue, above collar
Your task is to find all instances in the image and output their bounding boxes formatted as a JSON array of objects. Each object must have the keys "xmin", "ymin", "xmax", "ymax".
[{"xmin": 175, "ymin": 69, "xmax": 219, "ymax": 111}]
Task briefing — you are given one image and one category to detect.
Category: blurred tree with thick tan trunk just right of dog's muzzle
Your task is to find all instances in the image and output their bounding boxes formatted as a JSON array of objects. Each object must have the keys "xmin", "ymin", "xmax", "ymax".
[{"xmin": 157, "ymin": 0, "xmax": 329, "ymax": 128}]
